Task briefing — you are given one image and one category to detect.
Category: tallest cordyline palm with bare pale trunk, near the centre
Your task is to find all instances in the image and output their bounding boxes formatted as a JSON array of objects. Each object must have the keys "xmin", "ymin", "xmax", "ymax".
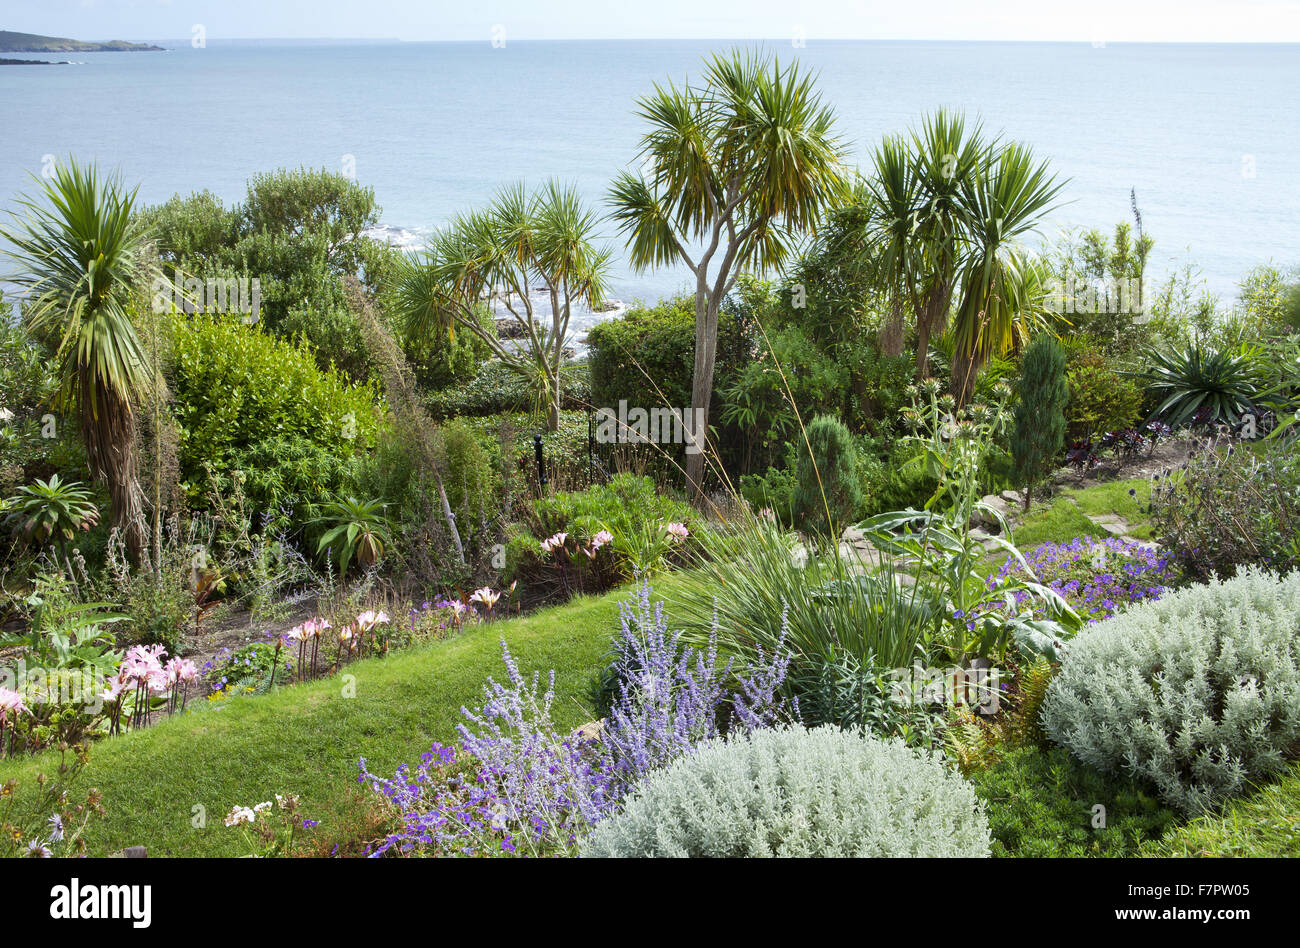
[{"xmin": 608, "ymin": 52, "xmax": 846, "ymax": 502}]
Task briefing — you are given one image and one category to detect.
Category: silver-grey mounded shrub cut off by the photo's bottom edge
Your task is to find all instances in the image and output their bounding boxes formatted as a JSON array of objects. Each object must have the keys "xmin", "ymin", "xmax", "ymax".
[{"xmin": 582, "ymin": 727, "xmax": 989, "ymax": 857}]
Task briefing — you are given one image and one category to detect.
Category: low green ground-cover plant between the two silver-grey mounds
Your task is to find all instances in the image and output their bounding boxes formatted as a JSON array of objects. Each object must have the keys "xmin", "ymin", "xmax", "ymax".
[{"xmin": 971, "ymin": 748, "xmax": 1179, "ymax": 858}]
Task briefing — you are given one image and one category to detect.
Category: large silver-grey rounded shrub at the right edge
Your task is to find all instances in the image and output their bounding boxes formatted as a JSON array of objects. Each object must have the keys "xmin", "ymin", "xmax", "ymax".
[{"xmin": 1043, "ymin": 570, "xmax": 1300, "ymax": 813}]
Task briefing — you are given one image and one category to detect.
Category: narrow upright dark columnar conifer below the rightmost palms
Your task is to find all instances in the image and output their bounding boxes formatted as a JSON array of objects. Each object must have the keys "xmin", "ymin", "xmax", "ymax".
[{"xmin": 1011, "ymin": 333, "xmax": 1070, "ymax": 508}]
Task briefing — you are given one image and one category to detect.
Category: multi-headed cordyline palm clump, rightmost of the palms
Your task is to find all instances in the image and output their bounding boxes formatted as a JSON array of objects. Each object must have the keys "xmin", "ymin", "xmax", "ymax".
[{"xmin": 865, "ymin": 109, "xmax": 1063, "ymax": 402}]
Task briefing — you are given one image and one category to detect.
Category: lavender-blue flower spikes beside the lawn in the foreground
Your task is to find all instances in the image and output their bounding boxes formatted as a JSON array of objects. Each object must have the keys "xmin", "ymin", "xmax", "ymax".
[{"xmin": 358, "ymin": 584, "xmax": 789, "ymax": 856}]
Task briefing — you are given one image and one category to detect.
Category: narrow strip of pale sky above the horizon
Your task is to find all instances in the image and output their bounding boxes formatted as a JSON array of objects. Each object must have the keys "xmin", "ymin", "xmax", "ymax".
[{"xmin": 0, "ymin": 0, "xmax": 1300, "ymax": 43}]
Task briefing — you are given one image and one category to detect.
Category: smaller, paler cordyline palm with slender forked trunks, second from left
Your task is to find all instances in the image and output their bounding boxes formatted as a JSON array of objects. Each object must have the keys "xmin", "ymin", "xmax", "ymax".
[{"xmin": 398, "ymin": 181, "xmax": 610, "ymax": 430}]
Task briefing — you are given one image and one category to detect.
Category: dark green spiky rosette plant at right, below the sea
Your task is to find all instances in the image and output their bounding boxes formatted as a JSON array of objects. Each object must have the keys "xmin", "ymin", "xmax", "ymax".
[{"xmin": 1145, "ymin": 342, "xmax": 1260, "ymax": 428}]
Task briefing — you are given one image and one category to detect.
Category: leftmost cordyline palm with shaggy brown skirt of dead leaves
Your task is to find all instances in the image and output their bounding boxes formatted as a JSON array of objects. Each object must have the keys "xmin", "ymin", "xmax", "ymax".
[{"xmin": 0, "ymin": 160, "xmax": 152, "ymax": 559}]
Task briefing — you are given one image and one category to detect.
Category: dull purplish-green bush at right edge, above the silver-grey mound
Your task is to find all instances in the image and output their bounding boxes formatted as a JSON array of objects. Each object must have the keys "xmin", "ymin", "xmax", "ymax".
[{"xmin": 1151, "ymin": 440, "xmax": 1300, "ymax": 579}]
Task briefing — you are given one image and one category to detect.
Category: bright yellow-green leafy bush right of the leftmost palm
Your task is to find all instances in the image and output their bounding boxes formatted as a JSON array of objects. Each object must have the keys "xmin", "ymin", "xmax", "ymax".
[{"xmin": 172, "ymin": 316, "xmax": 377, "ymax": 523}]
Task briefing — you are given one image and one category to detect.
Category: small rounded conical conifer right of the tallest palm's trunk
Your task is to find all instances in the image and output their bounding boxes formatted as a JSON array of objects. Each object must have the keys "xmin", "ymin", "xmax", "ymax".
[{"xmin": 793, "ymin": 415, "xmax": 862, "ymax": 536}]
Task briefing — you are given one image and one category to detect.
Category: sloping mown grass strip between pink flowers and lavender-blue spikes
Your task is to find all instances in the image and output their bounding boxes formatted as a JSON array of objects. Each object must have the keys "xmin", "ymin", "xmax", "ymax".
[{"xmin": 0, "ymin": 580, "xmax": 670, "ymax": 856}]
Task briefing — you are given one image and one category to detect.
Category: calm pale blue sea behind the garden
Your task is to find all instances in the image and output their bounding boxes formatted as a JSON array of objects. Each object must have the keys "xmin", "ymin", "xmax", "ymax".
[{"xmin": 0, "ymin": 38, "xmax": 1300, "ymax": 330}]
